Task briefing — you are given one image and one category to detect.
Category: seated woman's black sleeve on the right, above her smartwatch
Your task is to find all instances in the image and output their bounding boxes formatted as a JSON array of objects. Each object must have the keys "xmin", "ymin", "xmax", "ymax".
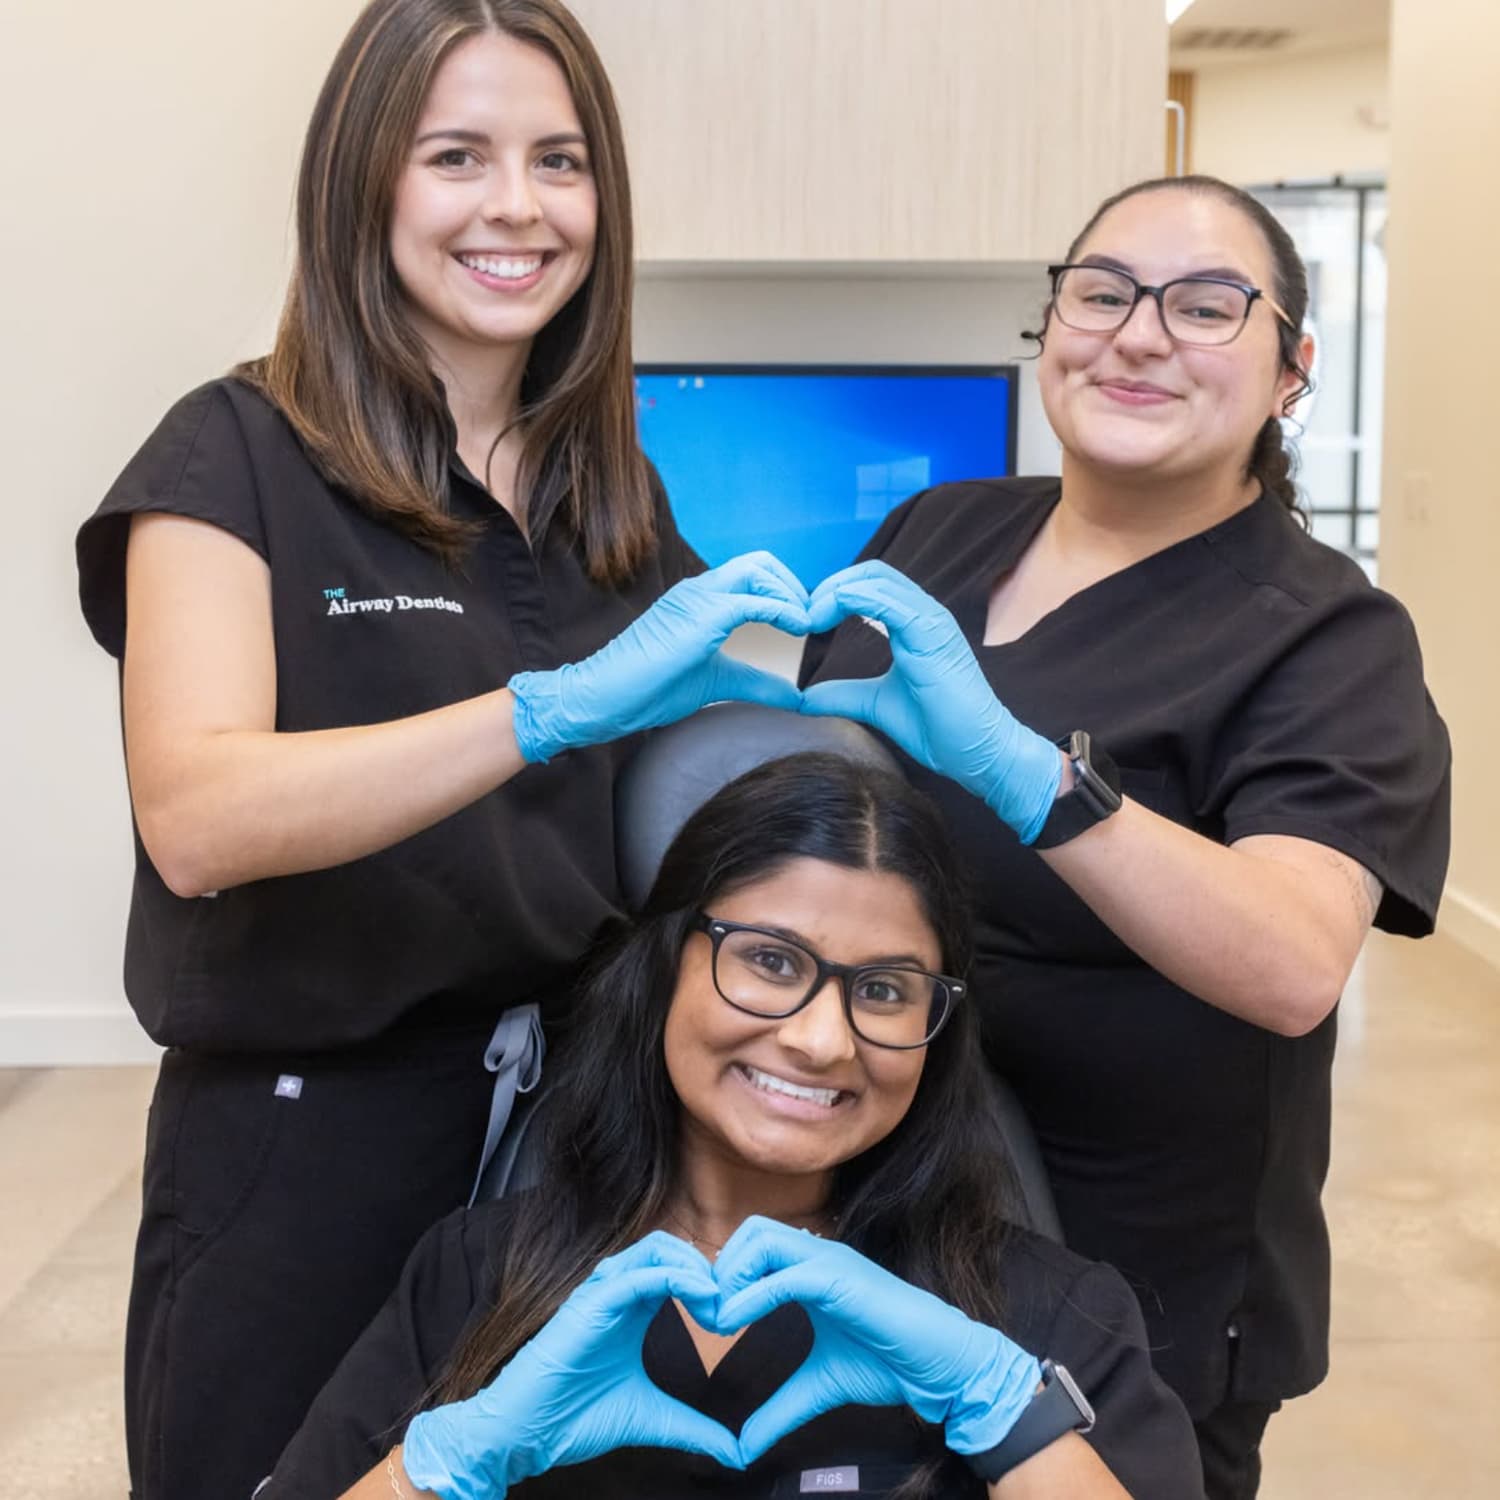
[{"xmin": 1043, "ymin": 1265, "xmax": 1203, "ymax": 1500}]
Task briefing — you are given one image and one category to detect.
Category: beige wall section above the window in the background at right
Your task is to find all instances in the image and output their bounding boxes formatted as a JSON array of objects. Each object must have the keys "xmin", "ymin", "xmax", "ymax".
[{"xmin": 1193, "ymin": 45, "xmax": 1391, "ymax": 185}]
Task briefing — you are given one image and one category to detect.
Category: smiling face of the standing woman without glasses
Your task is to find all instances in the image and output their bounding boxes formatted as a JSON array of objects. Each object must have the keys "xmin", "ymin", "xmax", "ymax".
[{"xmin": 390, "ymin": 32, "xmax": 599, "ymax": 375}]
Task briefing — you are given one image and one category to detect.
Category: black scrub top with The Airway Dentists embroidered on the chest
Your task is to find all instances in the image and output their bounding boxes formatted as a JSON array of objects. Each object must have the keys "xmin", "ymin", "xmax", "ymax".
[{"xmin": 78, "ymin": 378, "xmax": 701, "ymax": 1053}]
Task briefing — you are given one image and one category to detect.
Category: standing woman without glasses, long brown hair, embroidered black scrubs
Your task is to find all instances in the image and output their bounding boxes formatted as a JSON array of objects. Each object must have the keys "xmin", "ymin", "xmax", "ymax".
[{"xmin": 78, "ymin": 0, "xmax": 806, "ymax": 1500}]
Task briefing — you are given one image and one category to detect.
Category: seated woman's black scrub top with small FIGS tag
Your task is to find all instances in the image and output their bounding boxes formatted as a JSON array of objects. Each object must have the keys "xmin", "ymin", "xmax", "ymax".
[{"xmin": 257, "ymin": 1200, "xmax": 1203, "ymax": 1500}]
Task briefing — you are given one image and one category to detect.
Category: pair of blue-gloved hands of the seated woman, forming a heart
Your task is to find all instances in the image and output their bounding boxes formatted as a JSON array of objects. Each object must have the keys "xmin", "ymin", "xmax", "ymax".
[{"xmin": 402, "ymin": 1217, "xmax": 1041, "ymax": 1500}]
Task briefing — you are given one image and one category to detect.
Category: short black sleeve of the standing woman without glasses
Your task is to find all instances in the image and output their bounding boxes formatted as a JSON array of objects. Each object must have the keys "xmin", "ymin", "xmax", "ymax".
[{"xmin": 77, "ymin": 381, "xmax": 267, "ymax": 657}]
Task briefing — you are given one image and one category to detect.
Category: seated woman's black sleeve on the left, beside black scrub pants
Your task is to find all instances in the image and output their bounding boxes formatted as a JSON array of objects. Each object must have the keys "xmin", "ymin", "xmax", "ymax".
[{"xmin": 259, "ymin": 1209, "xmax": 492, "ymax": 1500}]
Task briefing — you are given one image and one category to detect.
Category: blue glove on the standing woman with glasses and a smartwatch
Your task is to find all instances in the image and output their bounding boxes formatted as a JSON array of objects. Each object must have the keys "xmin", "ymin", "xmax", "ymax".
[{"xmin": 803, "ymin": 563, "xmax": 1062, "ymax": 845}]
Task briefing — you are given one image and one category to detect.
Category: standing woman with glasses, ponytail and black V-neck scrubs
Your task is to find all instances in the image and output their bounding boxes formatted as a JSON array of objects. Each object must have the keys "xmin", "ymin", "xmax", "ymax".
[{"xmin": 803, "ymin": 177, "xmax": 1449, "ymax": 1500}]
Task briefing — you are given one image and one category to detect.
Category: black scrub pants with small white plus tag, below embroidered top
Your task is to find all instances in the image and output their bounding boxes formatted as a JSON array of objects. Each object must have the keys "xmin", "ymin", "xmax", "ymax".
[{"xmin": 125, "ymin": 1023, "xmax": 494, "ymax": 1500}]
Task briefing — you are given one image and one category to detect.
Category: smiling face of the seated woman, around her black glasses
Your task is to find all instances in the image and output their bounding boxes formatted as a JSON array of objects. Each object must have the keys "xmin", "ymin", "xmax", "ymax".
[{"xmin": 665, "ymin": 858, "xmax": 942, "ymax": 1178}]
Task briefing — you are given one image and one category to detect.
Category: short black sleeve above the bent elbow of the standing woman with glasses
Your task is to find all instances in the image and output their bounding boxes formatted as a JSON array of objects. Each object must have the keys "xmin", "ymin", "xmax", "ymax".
[{"xmin": 1206, "ymin": 590, "xmax": 1452, "ymax": 938}]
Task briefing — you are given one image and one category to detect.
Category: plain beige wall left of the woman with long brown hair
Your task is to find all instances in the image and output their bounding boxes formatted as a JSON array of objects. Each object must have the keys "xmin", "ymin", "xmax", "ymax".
[{"xmin": 0, "ymin": 0, "xmax": 369, "ymax": 1064}]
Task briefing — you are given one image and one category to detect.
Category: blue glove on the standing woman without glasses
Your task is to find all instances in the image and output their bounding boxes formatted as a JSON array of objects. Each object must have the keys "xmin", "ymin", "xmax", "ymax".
[{"xmin": 509, "ymin": 552, "xmax": 809, "ymax": 762}]
